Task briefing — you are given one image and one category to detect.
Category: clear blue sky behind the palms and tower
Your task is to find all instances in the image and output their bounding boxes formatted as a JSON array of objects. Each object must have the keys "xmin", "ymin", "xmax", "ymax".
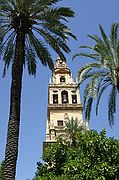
[{"xmin": 0, "ymin": 0, "xmax": 119, "ymax": 180}]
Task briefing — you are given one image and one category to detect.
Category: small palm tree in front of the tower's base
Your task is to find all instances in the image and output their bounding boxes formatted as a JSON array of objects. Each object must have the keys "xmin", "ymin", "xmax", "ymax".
[{"xmin": 65, "ymin": 117, "xmax": 86, "ymax": 147}]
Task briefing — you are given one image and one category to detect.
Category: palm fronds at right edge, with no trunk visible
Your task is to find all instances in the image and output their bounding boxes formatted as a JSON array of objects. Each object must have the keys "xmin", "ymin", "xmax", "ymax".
[{"xmin": 74, "ymin": 23, "xmax": 119, "ymax": 127}]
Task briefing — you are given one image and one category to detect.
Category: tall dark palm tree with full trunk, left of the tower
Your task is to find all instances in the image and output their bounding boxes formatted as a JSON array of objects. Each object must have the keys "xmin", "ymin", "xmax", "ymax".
[{"xmin": 0, "ymin": 0, "xmax": 76, "ymax": 180}]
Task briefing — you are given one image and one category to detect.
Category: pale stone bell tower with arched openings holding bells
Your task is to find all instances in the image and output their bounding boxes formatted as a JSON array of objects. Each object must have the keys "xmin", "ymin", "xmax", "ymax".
[{"xmin": 46, "ymin": 58, "xmax": 82, "ymax": 143}]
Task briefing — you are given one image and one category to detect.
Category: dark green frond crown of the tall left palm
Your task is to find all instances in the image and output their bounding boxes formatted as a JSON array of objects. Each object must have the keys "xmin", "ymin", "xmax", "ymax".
[{"xmin": 0, "ymin": 0, "xmax": 76, "ymax": 75}]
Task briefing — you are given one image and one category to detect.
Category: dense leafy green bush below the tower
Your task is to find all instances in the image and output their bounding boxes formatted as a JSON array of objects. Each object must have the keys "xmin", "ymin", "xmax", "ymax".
[{"xmin": 35, "ymin": 130, "xmax": 119, "ymax": 180}]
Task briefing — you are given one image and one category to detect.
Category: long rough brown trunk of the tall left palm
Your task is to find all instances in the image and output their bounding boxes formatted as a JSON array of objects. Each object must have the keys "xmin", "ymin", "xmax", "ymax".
[{"xmin": 4, "ymin": 32, "xmax": 25, "ymax": 180}]
